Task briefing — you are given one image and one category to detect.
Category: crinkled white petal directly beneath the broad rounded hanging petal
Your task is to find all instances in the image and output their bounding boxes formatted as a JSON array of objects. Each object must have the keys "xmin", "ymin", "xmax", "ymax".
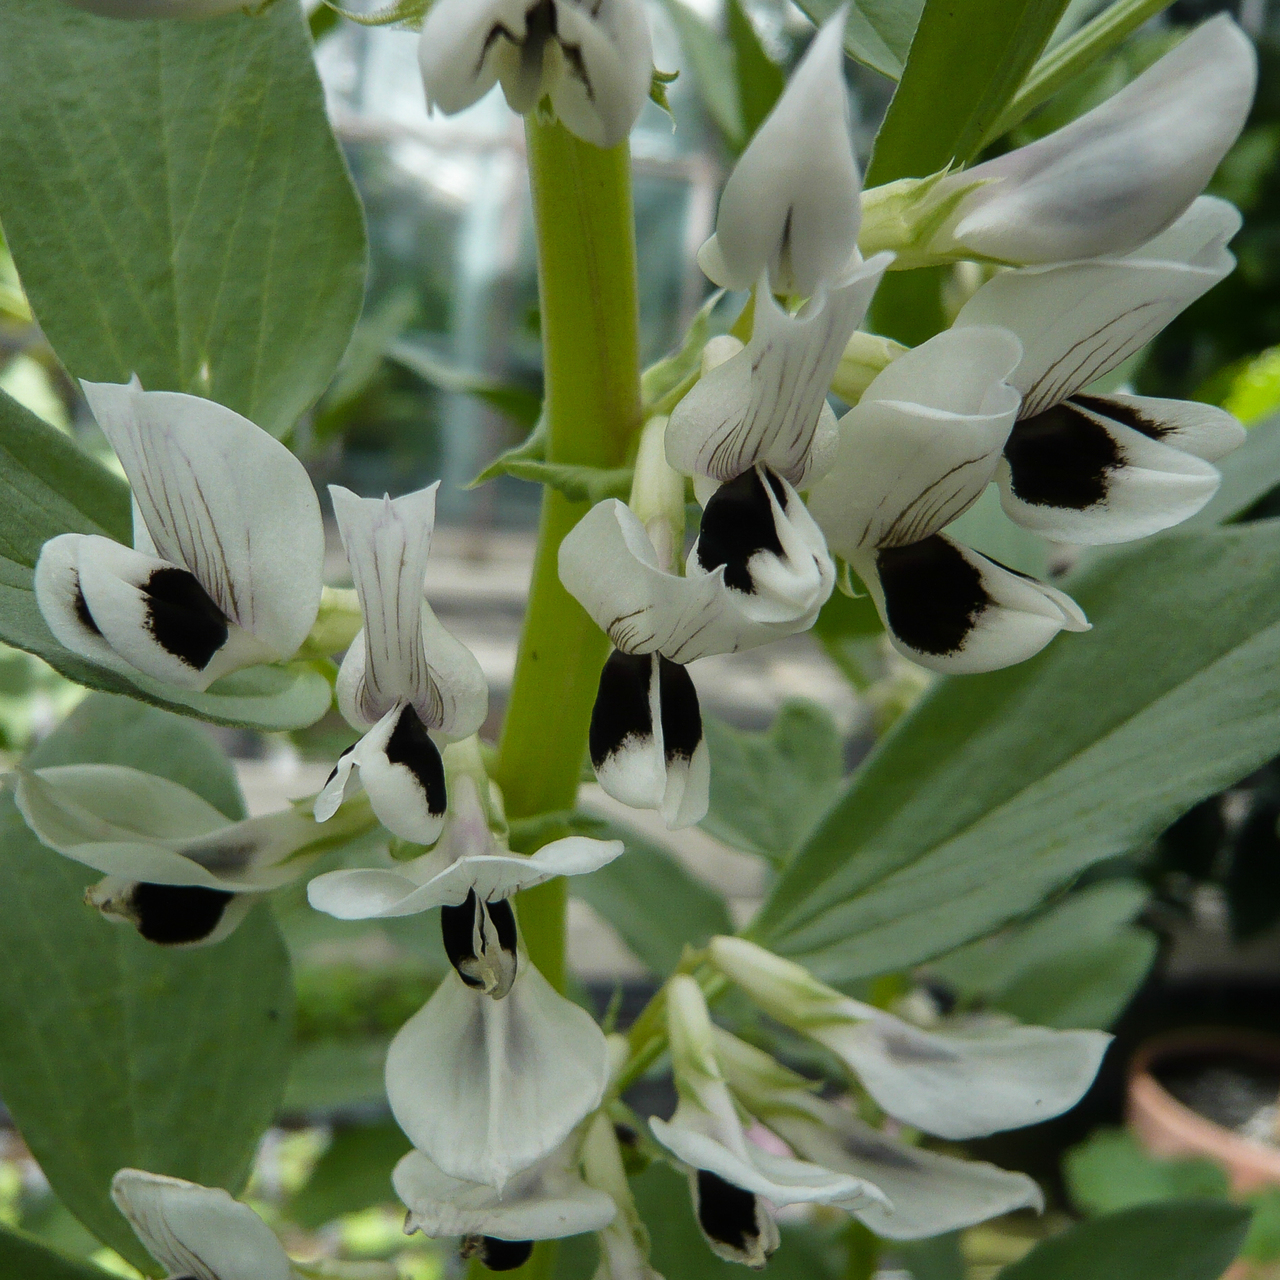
[{"xmin": 392, "ymin": 1151, "xmax": 617, "ymax": 1240}]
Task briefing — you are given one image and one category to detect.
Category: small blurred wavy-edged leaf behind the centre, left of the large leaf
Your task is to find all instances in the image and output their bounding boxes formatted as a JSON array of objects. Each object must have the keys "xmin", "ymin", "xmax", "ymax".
[{"xmin": 700, "ymin": 701, "xmax": 845, "ymax": 865}]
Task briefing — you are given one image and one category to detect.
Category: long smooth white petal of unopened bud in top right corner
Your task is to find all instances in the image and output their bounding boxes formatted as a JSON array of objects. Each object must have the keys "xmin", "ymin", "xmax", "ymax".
[{"xmin": 945, "ymin": 14, "xmax": 1257, "ymax": 262}]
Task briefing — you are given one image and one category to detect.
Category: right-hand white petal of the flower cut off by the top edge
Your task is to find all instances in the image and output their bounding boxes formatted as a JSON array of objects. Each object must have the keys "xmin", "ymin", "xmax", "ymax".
[{"xmin": 543, "ymin": 0, "xmax": 653, "ymax": 147}]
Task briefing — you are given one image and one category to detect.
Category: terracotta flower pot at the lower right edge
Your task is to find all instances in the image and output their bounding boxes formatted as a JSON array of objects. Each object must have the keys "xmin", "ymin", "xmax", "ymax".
[{"xmin": 1128, "ymin": 1028, "xmax": 1280, "ymax": 1194}]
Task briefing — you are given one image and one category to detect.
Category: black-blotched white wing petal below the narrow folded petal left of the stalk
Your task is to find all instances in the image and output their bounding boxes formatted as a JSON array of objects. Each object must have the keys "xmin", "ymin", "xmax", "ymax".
[{"xmin": 348, "ymin": 703, "xmax": 447, "ymax": 845}]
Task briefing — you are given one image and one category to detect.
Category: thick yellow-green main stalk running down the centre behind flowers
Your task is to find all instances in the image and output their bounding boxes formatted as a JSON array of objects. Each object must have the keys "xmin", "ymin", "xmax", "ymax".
[{"xmin": 472, "ymin": 114, "xmax": 641, "ymax": 1280}]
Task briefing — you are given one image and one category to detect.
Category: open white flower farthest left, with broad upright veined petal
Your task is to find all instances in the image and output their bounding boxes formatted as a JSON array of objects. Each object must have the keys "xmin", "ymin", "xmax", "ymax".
[{"xmin": 35, "ymin": 380, "xmax": 324, "ymax": 691}]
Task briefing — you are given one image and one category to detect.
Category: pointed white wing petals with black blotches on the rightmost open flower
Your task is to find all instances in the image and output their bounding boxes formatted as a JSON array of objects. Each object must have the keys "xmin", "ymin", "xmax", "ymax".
[{"xmin": 997, "ymin": 397, "xmax": 1218, "ymax": 545}]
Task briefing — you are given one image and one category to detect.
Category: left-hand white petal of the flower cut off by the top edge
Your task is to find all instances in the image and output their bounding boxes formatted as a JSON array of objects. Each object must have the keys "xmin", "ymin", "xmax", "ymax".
[{"xmin": 417, "ymin": 0, "xmax": 526, "ymax": 115}]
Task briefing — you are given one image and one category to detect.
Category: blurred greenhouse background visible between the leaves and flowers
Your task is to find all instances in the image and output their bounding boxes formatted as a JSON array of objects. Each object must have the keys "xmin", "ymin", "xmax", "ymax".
[{"xmin": 10, "ymin": 0, "xmax": 1280, "ymax": 1280}]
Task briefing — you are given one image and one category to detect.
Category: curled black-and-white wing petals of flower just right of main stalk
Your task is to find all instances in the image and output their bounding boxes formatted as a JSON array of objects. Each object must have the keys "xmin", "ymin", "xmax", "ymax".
[{"xmin": 685, "ymin": 466, "xmax": 836, "ymax": 635}]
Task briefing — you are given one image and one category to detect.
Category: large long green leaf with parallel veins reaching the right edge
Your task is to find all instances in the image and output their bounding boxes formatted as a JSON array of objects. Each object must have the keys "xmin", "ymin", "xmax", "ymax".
[{"xmin": 753, "ymin": 521, "xmax": 1280, "ymax": 982}]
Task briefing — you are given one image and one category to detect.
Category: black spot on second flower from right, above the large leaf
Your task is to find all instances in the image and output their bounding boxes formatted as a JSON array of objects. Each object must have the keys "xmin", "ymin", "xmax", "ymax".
[{"xmin": 876, "ymin": 535, "xmax": 991, "ymax": 655}]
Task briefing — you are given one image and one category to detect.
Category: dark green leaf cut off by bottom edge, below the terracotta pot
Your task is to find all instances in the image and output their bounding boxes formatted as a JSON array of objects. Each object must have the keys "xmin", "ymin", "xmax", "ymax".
[{"xmin": 1000, "ymin": 1199, "xmax": 1249, "ymax": 1280}]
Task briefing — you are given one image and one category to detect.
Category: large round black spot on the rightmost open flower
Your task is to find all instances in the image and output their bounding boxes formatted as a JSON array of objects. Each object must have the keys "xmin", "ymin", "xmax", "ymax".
[{"xmin": 1005, "ymin": 401, "xmax": 1124, "ymax": 511}]
